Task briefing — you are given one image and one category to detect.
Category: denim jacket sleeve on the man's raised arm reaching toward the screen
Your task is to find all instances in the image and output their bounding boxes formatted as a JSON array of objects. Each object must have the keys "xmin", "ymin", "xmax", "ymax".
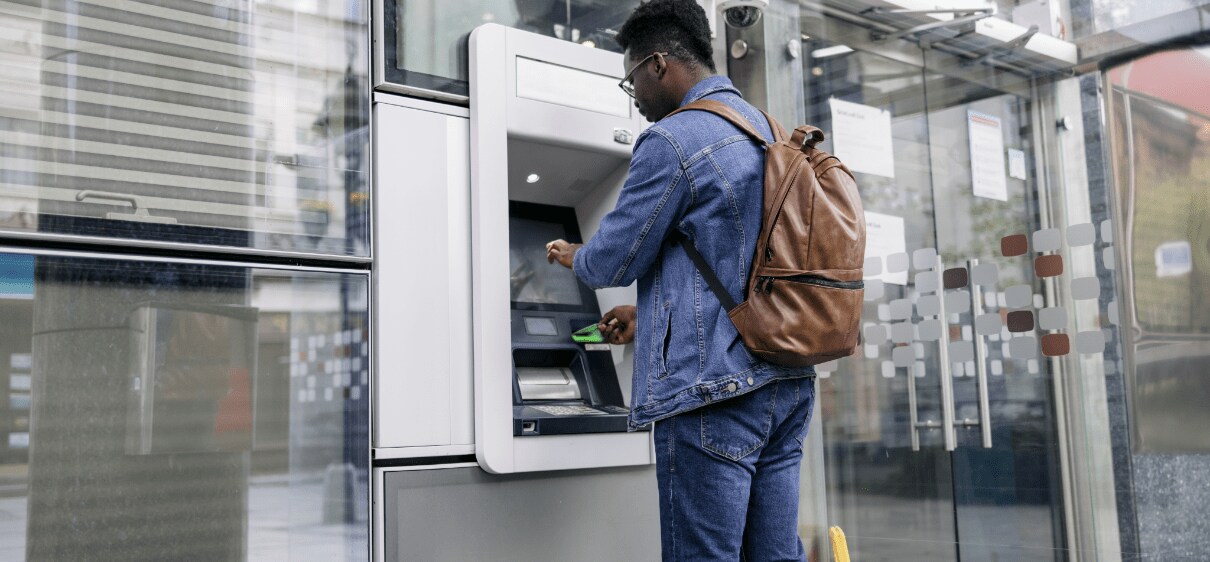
[{"xmin": 572, "ymin": 128, "xmax": 692, "ymax": 288}]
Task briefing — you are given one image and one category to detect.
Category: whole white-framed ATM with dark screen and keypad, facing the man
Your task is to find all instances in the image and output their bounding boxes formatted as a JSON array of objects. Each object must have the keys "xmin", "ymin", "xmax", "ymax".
[{"xmin": 471, "ymin": 24, "xmax": 655, "ymax": 474}]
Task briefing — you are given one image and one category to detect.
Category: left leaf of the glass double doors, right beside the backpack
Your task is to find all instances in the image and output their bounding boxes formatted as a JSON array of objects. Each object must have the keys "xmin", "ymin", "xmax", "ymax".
[{"xmin": 803, "ymin": 41, "xmax": 957, "ymax": 561}]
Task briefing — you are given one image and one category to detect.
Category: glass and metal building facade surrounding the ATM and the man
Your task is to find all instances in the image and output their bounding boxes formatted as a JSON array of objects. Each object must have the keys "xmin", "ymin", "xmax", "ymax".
[{"xmin": 0, "ymin": 0, "xmax": 1210, "ymax": 561}]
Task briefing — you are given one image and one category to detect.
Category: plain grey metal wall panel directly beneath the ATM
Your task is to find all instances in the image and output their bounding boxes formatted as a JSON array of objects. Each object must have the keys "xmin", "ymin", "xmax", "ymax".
[{"xmin": 382, "ymin": 466, "xmax": 659, "ymax": 562}]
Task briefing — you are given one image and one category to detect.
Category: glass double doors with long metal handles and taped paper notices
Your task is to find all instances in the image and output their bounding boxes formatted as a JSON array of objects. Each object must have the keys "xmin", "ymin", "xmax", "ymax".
[{"xmin": 803, "ymin": 34, "xmax": 1066, "ymax": 561}]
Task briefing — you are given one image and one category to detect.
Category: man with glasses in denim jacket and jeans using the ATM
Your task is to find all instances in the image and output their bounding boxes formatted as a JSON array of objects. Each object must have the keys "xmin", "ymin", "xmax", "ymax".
[{"xmin": 547, "ymin": 0, "xmax": 814, "ymax": 561}]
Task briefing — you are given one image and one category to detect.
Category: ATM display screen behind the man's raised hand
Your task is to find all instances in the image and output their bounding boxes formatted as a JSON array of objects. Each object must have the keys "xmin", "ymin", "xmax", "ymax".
[{"xmin": 508, "ymin": 217, "xmax": 583, "ymax": 306}]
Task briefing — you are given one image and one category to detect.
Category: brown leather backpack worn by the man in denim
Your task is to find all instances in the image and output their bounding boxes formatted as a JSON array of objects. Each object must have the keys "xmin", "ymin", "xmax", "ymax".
[{"xmin": 674, "ymin": 99, "xmax": 865, "ymax": 367}]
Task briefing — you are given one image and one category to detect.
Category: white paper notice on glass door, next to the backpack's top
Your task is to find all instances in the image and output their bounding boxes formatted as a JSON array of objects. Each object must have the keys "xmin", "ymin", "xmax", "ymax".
[{"xmin": 828, "ymin": 98, "xmax": 895, "ymax": 178}]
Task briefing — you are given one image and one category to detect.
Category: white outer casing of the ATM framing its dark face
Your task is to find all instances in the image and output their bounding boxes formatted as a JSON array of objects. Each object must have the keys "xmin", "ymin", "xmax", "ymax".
[{"xmin": 471, "ymin": 24, "xmax": 655, "ymax": 474}]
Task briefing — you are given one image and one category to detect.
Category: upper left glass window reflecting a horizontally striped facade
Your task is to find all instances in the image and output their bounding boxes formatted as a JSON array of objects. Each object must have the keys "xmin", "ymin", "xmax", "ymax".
[{"xmin": 0, "ymin": 0, "xmax": 369, "ymax": 256}]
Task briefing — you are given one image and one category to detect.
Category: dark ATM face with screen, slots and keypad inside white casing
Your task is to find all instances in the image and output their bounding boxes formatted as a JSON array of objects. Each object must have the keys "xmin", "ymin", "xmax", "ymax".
[{"xmin": 508, "ymin": 202, "xmax": 629, "ymax": 435}]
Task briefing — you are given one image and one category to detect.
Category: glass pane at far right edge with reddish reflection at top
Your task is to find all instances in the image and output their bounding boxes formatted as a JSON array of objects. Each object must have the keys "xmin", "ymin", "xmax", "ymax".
[{"xmin": 1108, "ymin": 48, "xmax": 1210, "ymax": 452}]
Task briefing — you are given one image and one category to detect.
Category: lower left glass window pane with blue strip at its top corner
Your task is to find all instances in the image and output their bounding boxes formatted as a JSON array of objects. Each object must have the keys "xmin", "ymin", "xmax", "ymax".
[{"xmin": 0, "ymin": 254, "xmax": 369, "ymax": 560}]
